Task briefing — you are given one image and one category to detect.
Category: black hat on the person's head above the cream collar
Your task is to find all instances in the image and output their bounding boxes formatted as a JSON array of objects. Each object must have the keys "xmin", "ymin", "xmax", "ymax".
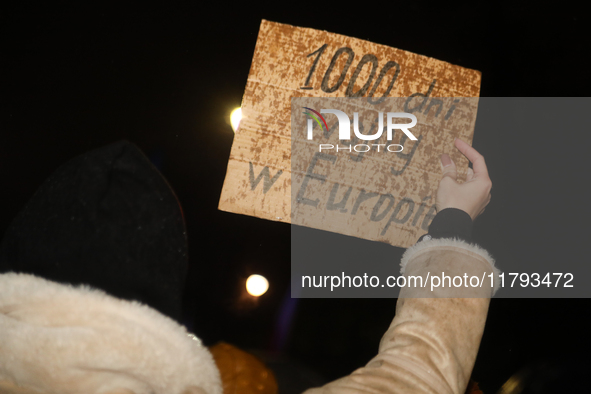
[{"xmin": 0, "ymin": 141, "xmax": 187, "ymax": 320}]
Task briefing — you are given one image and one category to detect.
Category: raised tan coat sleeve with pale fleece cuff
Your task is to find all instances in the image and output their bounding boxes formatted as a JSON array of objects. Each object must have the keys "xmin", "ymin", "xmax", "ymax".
[{"xmin": 306, "ymin": 240, "xmax": 497, "ymax": 394}]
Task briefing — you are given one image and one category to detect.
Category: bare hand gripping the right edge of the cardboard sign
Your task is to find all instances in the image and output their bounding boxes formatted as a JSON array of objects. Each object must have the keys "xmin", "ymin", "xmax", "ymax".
[{"xmin": 435, "ymin": 139, "xmax": 492, "ymax": 220}]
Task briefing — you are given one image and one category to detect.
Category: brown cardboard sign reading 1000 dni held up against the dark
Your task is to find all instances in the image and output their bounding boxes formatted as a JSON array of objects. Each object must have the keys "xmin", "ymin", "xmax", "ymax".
[{"xmin": 219, "ymin": 21, "xmax": 480, "ymax": 247}]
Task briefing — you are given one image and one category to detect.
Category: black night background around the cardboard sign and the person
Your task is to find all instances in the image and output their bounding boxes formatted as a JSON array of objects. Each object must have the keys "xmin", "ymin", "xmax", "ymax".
[{"xmin": 0, "ymin": 2, "xmax": 591, "ymax": 392}]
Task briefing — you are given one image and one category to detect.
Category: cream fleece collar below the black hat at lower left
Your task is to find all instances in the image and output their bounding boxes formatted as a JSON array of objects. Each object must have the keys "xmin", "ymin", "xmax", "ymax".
[{"xmin": 0, "ymin": 273, "xmax": 222, "ymax": 394}]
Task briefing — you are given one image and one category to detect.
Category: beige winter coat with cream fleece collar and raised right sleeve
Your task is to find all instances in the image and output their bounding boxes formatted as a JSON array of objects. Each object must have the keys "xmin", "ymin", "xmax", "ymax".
[{"xmin": 0, "ymin": 240, "xmax": 496, "ymax": 394}]
